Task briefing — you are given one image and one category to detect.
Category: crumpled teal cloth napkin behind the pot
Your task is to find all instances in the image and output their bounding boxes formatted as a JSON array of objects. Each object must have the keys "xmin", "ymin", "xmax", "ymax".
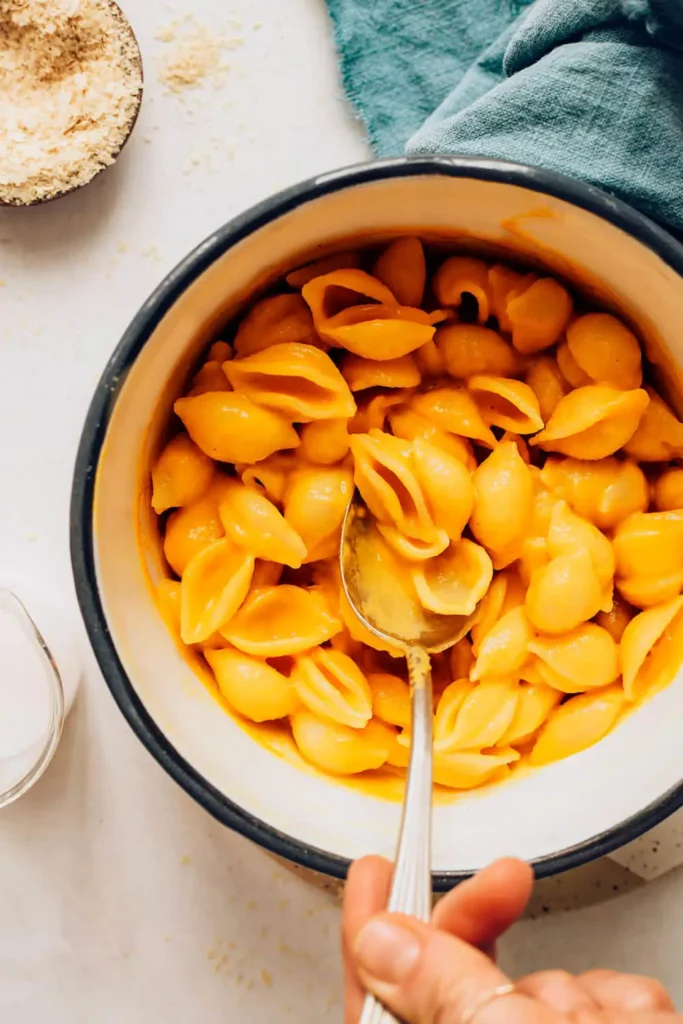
[{"xmin": 327, "ymin": 0, "xmax": 683, "ymax": 234}]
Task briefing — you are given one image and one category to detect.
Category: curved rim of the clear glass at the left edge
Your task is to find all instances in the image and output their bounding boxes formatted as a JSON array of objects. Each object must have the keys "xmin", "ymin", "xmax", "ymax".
[{"xmin": 0, "ymin": 587, "xmax": 65, "ymax": 810}]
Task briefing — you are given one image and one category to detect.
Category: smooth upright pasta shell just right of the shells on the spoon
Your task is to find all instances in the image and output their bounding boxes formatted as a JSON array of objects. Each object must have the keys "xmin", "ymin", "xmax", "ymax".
[{"xmin": 470, "ymin": 441, "xmax": 533, "ymax": 568}]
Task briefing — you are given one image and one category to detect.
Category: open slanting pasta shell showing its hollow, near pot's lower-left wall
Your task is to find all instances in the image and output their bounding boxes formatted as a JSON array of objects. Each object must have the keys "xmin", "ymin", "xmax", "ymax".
[{"xmin": 180, "ymin": 538, "xmax": 254, "ymax": 643}]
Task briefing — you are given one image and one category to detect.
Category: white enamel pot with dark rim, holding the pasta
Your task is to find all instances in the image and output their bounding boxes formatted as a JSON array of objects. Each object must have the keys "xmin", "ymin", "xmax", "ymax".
[{"xmin": 72, "ymin": 157, "xmax": 683, "ymax": 889}]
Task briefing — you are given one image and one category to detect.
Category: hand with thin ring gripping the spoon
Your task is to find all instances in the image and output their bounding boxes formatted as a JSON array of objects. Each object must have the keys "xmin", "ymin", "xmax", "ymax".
[{"xmin": 342, "ymin": 857, "xmax": 683, "ymax": 1024}]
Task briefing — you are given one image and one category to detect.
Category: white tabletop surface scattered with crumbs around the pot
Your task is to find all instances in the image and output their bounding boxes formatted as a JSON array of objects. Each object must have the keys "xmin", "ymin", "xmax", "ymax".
[{"xmin": 0, "ymin": 0, "xmax": 683, "ymax": 1024}]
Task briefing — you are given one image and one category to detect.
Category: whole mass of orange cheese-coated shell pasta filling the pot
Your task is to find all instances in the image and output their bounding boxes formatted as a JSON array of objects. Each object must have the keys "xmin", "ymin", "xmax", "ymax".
[{"xmin": 151, "ymin": 236, "xmax": 683, "ymax": 796}]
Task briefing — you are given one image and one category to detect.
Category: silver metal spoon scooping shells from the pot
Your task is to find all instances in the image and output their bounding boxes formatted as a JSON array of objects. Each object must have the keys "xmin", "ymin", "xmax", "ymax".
[{"xmin": 340, "ymin": 492, "xmax": 476, "ymax": 1024}]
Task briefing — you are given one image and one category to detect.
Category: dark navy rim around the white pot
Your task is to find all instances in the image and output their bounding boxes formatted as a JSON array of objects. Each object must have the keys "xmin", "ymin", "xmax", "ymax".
[{"xmin": 70, "ymin": 156, "xmax": 683, "ymax": 892}]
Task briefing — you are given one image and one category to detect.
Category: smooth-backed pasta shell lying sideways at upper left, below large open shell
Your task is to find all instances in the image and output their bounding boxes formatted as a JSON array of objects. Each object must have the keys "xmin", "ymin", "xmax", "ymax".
[{"xmin": 173, "ymin": 391, "xmax": 296, "ymax": 463}]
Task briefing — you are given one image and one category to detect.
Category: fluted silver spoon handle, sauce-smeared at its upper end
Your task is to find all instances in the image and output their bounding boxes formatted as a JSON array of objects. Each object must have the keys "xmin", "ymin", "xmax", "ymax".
[{"xmin": 359, "ymin": 647, "xmax": 433, "ymax": 1024}]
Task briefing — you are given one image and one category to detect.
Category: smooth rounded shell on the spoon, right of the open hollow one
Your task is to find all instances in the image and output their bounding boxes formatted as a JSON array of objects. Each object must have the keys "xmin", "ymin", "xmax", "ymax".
[{"xmin": 413, "ymin": 437, "xmax": 474, "ymax": 541}]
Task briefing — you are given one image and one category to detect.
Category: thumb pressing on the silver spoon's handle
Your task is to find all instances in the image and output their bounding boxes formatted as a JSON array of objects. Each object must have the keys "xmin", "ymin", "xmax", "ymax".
[{"xmin": 352, "ymin": 913, "xmax": 564, "ymax": 1024}]
